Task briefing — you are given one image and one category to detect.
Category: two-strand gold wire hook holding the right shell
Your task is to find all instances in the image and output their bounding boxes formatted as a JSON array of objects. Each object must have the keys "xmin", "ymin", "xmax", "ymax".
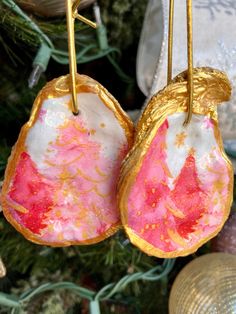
[{"xmin": 167, "ymin": 0, "xmax": 194, "ymax": 126}]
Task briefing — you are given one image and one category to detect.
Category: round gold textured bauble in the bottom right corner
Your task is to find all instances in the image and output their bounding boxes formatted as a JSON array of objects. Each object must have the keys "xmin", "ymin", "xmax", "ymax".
[{"xmin": 169, "ymin": 253, "xmax": 236, "ymax": 314}]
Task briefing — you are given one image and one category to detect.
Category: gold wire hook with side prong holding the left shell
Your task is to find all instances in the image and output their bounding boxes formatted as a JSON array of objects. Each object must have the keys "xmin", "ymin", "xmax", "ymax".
[{"xmin": 65, "ymin": 0, "xmax": 97, "ymax": 115}]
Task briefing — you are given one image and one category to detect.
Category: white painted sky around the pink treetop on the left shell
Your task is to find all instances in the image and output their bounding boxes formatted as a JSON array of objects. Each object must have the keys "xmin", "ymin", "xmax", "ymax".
[{"xmin": 26, "ymin": 93, "xmax": 127, "ymax": 170}]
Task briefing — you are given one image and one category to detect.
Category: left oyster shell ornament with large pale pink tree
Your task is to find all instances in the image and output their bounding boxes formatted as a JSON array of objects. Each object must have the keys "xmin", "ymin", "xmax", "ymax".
[{"xmin": 2, "ymin": 75, "xmax": 133, "ymax": 246}]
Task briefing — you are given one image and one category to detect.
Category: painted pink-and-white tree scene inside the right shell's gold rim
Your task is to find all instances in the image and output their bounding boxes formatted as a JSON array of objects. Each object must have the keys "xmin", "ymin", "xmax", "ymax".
[{"xmin": 124, "ymin": 113, "xmax": 230, "ymax": 254}]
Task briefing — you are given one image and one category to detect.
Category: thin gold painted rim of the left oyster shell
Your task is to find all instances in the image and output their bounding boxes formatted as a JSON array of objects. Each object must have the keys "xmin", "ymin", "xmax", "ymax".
[{"xmin": 1, "ymin": 74, "xmax": 134, "ymax": 247}]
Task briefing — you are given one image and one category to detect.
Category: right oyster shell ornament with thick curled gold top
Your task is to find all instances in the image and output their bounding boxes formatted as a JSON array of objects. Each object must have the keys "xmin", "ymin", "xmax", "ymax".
[{"xmin": 118, "ymin": 68, "xmax": 233, "ymax": 258}]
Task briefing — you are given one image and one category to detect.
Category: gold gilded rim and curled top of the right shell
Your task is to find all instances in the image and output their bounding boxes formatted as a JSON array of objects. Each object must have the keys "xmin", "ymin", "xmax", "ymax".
[{"xmin": 117, "ymin": 68, "xmax": 233, "ymax": 258}]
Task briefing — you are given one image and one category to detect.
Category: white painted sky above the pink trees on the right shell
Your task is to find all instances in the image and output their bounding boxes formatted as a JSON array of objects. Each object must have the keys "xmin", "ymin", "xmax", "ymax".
[{"xmin": 166, "ymin": 113, "xmax": 221, "ymax": 182}]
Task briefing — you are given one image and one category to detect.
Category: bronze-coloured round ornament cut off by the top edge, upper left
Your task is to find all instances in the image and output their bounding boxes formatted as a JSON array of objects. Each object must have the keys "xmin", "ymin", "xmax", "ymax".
[{"xmin": 16, "ymin": 0, "xmax": 95, "ymax": 17}]
